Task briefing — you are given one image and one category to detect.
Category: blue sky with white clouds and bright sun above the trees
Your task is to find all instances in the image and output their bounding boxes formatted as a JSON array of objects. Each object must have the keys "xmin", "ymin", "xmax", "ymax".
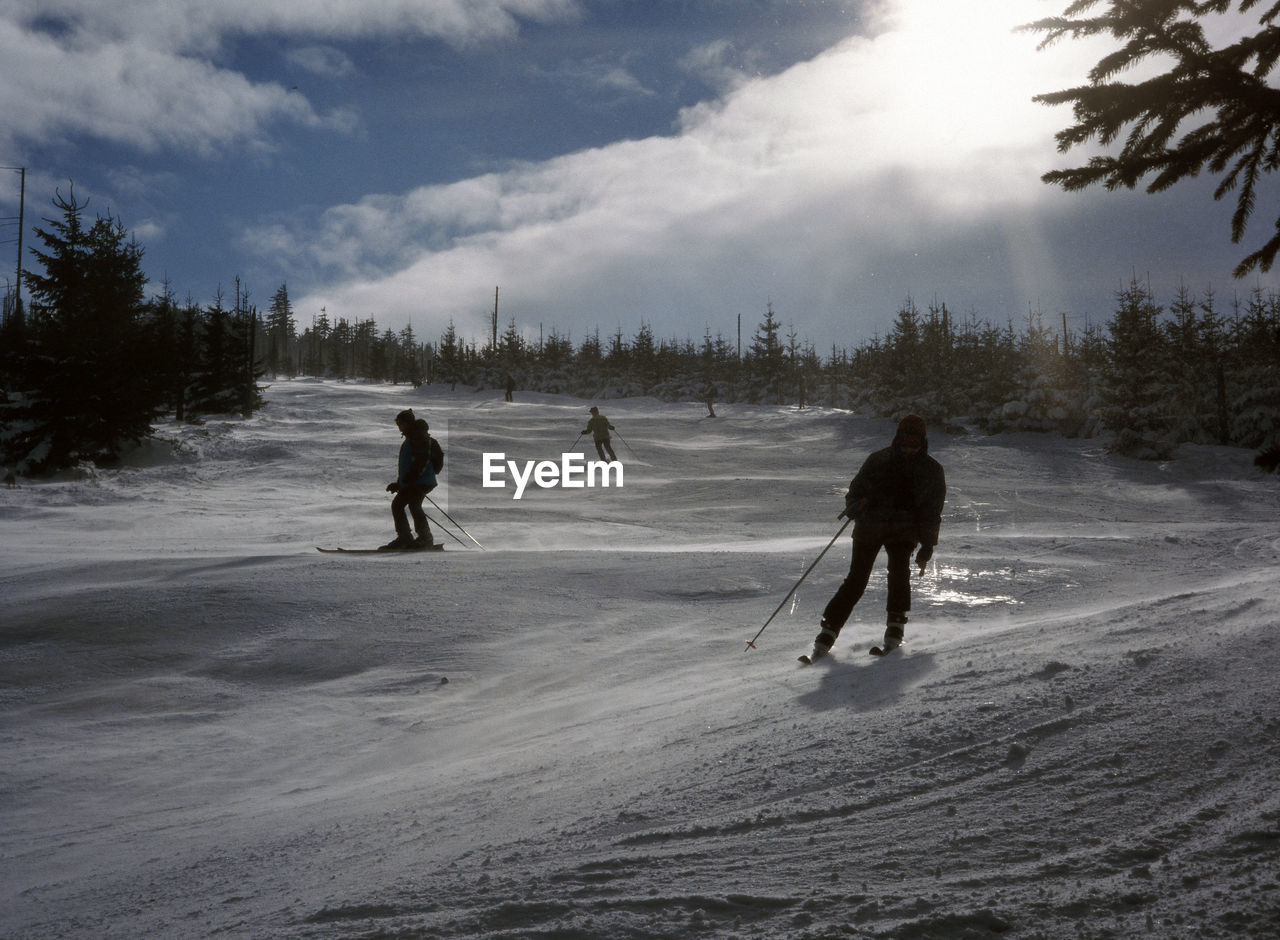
[{"xmin": 0, "ymin": 0, "xmax": 1274, "ymax": 351}]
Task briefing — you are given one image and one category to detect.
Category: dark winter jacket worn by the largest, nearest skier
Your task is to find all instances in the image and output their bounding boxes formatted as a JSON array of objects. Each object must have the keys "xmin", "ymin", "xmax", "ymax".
[{"xmin": 845, "ymin": 432, "xmax": 947, "ymax": 546}]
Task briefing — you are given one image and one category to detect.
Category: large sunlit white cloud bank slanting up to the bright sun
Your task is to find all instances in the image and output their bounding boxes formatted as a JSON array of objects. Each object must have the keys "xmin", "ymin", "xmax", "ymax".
[{"xmin": 285, "ymin": 0, "xmax": 1116, "ymax": 334}]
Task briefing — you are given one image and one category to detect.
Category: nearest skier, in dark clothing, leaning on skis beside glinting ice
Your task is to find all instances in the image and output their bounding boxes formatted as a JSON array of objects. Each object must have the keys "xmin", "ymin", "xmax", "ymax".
[{"xmin": 812, "ymin": 415, "xmax": 947, "ymax": 660}]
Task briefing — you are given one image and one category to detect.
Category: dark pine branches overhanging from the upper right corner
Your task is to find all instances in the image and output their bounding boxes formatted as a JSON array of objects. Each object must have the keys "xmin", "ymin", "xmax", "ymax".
[{"xmin": 1025, "ymin": 0, "xmax": 1280, "ymax": 277}]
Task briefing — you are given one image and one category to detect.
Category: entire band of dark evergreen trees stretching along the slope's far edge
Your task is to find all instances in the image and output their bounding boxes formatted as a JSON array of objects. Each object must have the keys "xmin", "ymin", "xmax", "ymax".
[{"xmin": 0, "ymin": 193, "xmax": 1280, "ymax": 474}]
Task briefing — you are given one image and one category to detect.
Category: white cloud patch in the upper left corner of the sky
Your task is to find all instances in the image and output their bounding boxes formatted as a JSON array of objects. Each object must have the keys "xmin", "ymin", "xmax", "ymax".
[{"xmin": 0, "ymin": 0, "xmax": 577, "ymax": 152}]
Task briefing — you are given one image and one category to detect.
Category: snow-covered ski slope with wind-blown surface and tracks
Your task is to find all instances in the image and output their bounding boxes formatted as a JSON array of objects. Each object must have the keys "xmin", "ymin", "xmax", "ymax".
[{"xmin": 0, "ymin": 380, "xmax": 1280, "ymax": 937}]
